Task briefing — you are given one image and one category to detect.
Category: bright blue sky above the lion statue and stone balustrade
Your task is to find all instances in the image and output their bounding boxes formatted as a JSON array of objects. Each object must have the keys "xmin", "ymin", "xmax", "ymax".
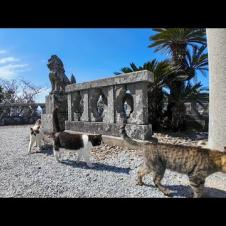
[{"xmin": 0, "ymin": 29, "xmax": 208, "ymax": 102}]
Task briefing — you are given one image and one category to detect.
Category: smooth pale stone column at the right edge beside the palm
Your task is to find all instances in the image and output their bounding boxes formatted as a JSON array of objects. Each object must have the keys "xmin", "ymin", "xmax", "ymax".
[{"xmin": 207, "ymin": 28, "xmax": 226, "ymax": 151}]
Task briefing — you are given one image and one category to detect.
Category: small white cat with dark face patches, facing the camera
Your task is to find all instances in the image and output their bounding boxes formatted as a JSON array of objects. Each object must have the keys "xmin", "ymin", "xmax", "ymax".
[{"xmin": 28, "ymin": 119, "xmax": 44, "ymax": 154}]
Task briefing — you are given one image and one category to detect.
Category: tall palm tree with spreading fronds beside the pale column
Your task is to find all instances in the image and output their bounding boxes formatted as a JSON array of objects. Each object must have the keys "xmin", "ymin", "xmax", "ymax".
[{"xmin": 148, "ymin": 28, "xmax": 208, "ymax": 131}]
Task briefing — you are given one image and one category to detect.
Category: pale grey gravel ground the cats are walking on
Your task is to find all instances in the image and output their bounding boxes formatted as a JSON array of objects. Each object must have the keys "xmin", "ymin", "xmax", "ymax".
[{"xmin": 0, "ymin": 125, "xmax": 226, "ymax": 198}]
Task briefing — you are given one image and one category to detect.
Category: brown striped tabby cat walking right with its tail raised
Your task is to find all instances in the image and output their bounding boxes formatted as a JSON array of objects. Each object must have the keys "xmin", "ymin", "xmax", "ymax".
[{"xmin": 121, "ymin": 123, "xmax": 226, "ymax": 198}]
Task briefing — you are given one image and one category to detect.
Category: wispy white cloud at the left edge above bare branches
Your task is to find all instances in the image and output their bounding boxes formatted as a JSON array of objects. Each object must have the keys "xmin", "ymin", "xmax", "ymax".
[{"xmin": 0, "ymin": 64, "xmax": 28, "ymax": 80}]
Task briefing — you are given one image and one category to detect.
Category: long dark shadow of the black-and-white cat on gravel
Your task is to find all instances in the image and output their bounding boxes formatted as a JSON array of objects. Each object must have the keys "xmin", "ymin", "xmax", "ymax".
[{"xmin": 60, "ymin": 160, "xmax": 131, "ymax": 174}]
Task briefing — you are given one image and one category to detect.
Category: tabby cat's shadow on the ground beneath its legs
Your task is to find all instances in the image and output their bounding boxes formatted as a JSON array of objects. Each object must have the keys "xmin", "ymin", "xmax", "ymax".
[{"xmin": 144, "ymin": 183, "xmax": 226, "ymax": 198}]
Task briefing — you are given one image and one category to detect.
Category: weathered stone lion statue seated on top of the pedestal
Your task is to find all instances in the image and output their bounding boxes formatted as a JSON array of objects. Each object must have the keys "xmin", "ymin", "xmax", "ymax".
[{"xmin": 47, "ymin": 55, "xmax": 71, "ymax": 92}]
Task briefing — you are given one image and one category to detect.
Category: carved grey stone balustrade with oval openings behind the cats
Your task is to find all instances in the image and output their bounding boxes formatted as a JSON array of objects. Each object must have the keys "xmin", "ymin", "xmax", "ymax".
[{"xmin": 65, "ymin": 70, "xmax": 153, "ymax": 140}]
